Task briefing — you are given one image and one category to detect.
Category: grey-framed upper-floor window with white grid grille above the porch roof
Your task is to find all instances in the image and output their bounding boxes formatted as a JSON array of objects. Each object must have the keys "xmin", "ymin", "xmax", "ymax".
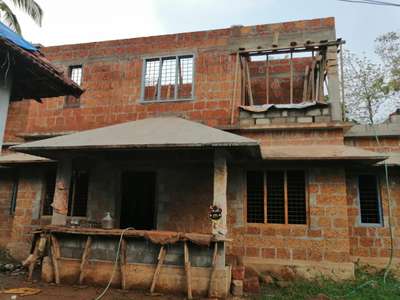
[{"xmin": 142, "ymin": 55, "xmax": 194, "ymax": 101}]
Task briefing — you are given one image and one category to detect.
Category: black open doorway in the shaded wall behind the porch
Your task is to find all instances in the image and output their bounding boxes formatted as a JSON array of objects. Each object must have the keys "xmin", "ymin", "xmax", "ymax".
[{"xmin": 120, "ymin": 171, "xmax": 156, "ymax": 230}]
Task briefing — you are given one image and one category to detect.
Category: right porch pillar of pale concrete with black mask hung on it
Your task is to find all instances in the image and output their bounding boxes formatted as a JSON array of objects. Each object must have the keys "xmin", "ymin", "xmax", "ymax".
[{"xmin": 212, "ymin": 150, "xmax": 228, "ymax": 268}]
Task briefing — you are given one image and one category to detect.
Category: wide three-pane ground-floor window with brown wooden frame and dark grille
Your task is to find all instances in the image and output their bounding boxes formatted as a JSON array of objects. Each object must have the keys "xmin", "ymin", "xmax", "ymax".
[{"xmin": 247, "ymin": 170, "xmax": 307, "ymax": 224}]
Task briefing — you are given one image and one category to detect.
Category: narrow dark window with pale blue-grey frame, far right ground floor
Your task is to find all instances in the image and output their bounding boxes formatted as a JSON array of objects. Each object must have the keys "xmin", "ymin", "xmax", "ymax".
[{"xmin": 358, "ymin": 175, "xmax": 382, "ymax": 224}]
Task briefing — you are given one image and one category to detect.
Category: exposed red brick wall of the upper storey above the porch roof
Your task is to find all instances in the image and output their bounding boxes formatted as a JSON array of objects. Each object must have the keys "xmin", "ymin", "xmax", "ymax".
[{"xmin": 6, "ymin": 18, "xmax": 335, "ymax": 141}]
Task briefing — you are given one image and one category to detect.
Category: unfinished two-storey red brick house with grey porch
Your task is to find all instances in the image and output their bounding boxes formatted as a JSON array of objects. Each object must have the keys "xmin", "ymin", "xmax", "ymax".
[{"xmin": 0, "ymin": 18, "xmax": 400, "ymax": 297}]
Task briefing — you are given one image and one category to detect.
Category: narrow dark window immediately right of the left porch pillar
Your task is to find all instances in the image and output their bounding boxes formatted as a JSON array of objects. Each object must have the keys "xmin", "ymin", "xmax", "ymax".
[{"xmin": 68, "ymin": 170, "xmax": 89, "ymax": 217}]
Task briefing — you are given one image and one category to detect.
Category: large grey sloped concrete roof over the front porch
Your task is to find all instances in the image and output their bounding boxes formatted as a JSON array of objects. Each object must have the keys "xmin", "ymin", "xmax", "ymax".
[{"xmin": 12, "ymin": 117, "xmax": 258, "ymax": 153}]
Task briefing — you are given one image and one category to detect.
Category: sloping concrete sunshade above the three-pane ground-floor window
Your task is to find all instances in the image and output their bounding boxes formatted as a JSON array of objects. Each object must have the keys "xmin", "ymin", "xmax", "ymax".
[{"xmin": 261, "ymin": 145, "xmax": 388, "ymax": 163}]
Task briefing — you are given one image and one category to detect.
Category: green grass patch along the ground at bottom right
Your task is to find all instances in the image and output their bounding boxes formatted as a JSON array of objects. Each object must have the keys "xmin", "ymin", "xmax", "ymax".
[{"xmin": 255, "ymin": 268, "xmax": 400, "ymax": 300}]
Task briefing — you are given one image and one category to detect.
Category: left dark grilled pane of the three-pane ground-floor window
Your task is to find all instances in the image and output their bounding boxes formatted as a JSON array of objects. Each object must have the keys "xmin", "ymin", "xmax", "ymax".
[{"xmin": 247, "ymin": 171, "xmax": 265, "ymax": 223}]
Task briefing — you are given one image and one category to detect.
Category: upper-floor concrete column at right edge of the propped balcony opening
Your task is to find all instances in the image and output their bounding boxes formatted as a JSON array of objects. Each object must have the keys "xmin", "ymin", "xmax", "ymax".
[{"xmin": 326, "ymin": 46, "xmax": 342, "ymax": 121}]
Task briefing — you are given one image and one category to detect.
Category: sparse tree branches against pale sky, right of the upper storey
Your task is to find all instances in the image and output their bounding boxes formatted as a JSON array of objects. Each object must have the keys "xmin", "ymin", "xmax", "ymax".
[{"xmin": 343, "ymin": 32, "xmax": 400, "ymax": 124}]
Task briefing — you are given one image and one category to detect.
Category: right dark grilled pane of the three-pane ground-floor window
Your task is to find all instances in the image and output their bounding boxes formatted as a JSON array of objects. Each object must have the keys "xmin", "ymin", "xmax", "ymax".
[{"xmin": 286, "ymin": 170, "xmax": 307, "ymax": 224}]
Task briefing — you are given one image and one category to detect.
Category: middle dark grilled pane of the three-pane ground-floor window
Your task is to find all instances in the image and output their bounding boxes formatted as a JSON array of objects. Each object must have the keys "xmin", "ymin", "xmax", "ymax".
[{"xmin": 267, "ymin": 171, "xmax": 285, "ymax": 224}]
